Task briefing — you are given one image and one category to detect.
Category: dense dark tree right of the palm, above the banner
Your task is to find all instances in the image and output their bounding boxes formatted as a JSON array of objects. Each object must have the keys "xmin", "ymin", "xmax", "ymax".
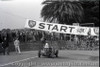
[{"xmin": 80, "ymin": 1, "xmax": 99, "ymax": 26}]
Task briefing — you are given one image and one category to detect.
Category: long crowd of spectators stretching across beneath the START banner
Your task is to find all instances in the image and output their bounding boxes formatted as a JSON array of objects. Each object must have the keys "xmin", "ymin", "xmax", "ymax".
[{"xmin": 0, "ymin": 29, "xmax": 99, "ymax": 49}]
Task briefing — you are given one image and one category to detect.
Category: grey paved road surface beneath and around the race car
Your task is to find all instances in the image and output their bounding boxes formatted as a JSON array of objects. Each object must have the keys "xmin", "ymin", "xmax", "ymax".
[{"xmin": 0, "ymin": 50, "xmax": 99, "ymax": 67}]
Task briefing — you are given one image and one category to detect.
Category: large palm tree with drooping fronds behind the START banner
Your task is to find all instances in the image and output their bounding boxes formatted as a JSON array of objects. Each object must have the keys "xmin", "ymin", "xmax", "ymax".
[{"xmin": 41, "ymin": 1, "xmax": 83, "ymax": 24}]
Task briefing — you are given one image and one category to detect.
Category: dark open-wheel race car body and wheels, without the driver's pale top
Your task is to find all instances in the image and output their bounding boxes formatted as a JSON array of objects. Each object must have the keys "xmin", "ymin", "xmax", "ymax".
[{"xmin": 38, "ymin": 41, "xmax": 59, "ymax": 58}]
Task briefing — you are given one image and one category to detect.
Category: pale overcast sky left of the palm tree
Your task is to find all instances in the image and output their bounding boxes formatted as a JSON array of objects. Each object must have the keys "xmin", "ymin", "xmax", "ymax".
[{"xmin": 0, "ymin": 0, "xmax": 43, "ymax": 30}]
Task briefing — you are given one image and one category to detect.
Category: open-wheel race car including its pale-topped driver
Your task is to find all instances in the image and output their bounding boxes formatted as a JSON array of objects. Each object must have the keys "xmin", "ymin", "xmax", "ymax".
[{"xmin": 38, "ymin": 41, "xmax": 59, "ymax": 58}]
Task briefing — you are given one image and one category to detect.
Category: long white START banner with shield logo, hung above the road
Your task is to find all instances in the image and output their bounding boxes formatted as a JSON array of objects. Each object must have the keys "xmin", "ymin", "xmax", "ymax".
[{"xmin": 25, "ymin": 19, "xmax": 99, "ymax": 36}]
